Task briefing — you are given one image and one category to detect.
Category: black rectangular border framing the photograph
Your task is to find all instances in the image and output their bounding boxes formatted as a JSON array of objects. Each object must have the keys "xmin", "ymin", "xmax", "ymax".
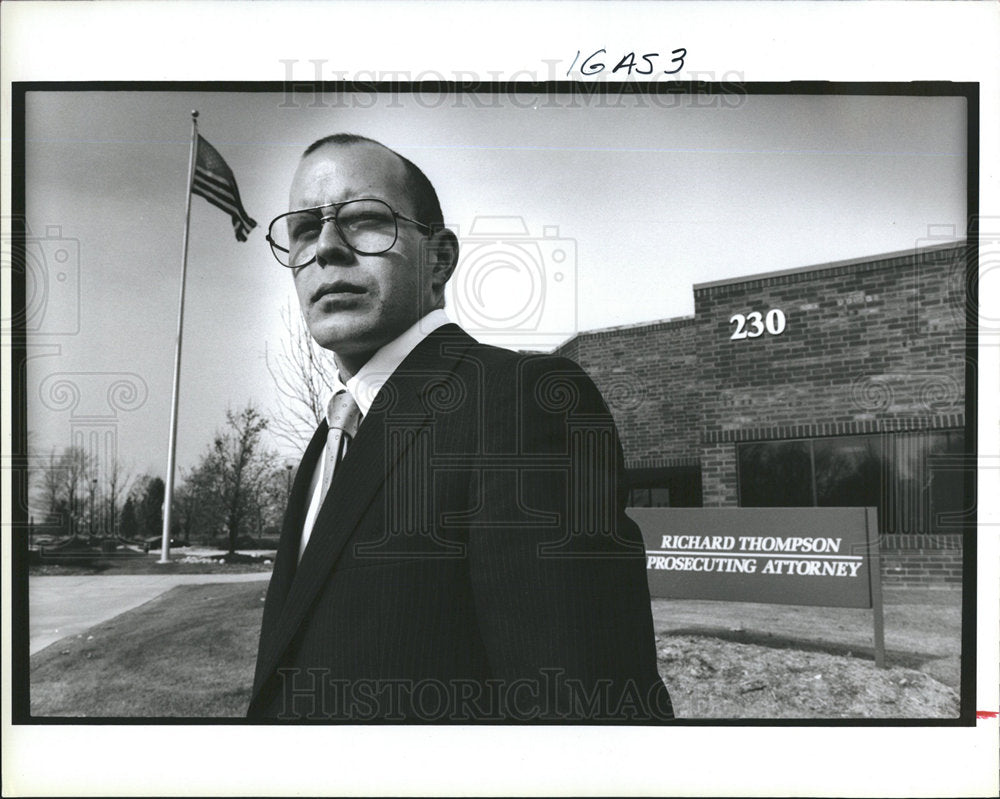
[{"xmin": 8, "ymin": 80, "xmax": 980, "ymax": 727}]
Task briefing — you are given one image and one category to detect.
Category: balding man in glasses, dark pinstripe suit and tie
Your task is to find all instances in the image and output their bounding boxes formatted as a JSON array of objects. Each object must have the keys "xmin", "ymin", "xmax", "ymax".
[{"xmin": 248, "ymin": 134, "xmax": 672, "ymax": 723}]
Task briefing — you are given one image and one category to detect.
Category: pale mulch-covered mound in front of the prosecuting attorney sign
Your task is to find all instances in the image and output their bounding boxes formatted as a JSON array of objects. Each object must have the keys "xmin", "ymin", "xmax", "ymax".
[{"xmin": 656, "ymin": 635, "xmax": 959, "ymax": 719}]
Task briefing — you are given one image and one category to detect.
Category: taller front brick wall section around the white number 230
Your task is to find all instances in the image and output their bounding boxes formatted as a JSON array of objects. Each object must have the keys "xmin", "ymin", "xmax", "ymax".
[{"xmin": 695, "ymin": 248, "xmax": 965, "ymax": 432}]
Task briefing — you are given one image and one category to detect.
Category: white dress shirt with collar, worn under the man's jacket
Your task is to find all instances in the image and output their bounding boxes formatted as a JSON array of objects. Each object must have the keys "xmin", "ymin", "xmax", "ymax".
[{"xmin": 299, "ymin": 308, "xmax": 451, "ymax": 560}]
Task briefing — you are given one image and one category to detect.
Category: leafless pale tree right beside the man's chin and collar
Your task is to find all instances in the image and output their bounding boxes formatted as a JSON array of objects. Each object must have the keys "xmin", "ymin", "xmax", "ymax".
[{"xmin": 264, "ymin": 305, "xmax": 337, "ymax": 448}]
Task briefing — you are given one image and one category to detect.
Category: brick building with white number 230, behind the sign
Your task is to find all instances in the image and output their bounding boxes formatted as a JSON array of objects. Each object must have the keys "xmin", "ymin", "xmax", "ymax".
[{"xmin": 557, "ymin": 243, "xmax": 966, "ymax": 583}]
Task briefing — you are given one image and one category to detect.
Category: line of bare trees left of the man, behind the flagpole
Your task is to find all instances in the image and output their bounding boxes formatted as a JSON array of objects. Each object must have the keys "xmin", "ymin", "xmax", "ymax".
[{"xmin": 29, "ymin": 307, "xmax": 336, "ymax": 553}]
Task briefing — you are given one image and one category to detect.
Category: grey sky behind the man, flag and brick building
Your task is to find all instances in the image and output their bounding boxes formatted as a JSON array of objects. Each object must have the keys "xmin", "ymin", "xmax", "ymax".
[{"xmin": 26, "ymin": 92, "xmax": 966, "ymax": 476}]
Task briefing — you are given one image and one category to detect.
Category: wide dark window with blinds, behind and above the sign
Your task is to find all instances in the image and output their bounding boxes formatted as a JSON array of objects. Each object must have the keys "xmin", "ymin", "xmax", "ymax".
[{"xmin": 737, "ymin": 430, "xmax": 964, "ymax": 534}]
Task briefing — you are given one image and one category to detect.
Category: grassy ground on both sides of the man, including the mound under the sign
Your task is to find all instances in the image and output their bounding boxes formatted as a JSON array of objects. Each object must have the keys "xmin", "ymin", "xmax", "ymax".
[{"xmin": 31, "ymin": 581, "xmax": 961, "ymax": 719}]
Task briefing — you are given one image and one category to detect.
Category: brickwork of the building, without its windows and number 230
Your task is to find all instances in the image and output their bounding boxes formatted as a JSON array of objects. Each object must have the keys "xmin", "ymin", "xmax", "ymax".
[{"xmin": 559, "ymin": 245, "xmax": 966, "ymax": 581}]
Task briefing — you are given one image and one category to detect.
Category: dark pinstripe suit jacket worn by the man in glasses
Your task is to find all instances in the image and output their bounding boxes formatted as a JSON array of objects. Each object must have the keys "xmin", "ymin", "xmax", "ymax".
[{"xmin": 248, "ymin": 325, "xmax": 672, "ymax": 723}]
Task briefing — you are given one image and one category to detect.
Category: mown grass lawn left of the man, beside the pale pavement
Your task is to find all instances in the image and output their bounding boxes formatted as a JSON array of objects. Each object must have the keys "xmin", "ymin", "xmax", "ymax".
[{"xmin": 31, "ymin": 581, "xmax": 267, "ymax": 718}]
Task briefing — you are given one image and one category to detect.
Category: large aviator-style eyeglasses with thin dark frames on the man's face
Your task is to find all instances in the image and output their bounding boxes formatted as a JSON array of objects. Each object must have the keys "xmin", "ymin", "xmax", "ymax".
[{"xmin": 267, "ymin": 199, "xmax": 431, "ymax": 269}]
